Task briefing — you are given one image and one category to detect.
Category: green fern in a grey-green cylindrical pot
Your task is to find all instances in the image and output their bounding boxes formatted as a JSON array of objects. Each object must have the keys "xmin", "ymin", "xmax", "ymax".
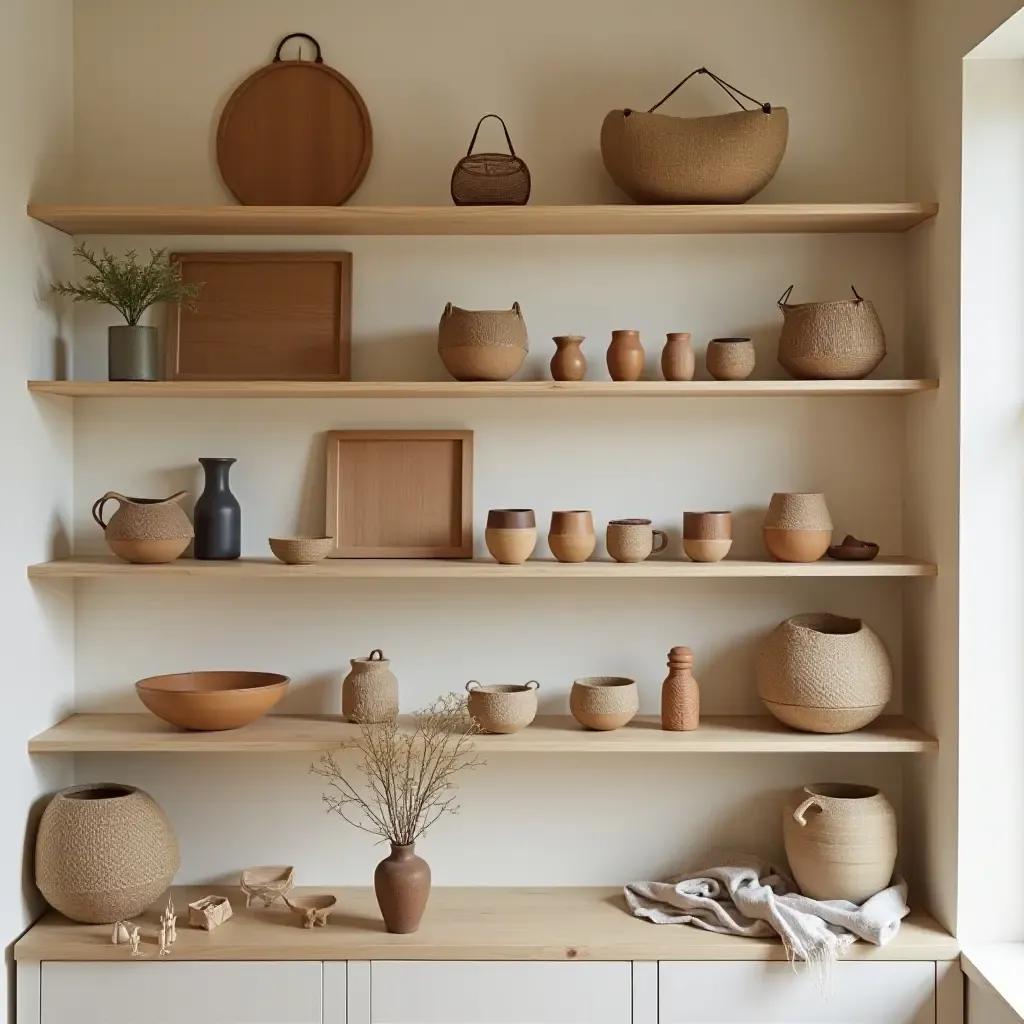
[{"xmin": 53, "ymin": 245, "xmax": 201, "ymax": 381}]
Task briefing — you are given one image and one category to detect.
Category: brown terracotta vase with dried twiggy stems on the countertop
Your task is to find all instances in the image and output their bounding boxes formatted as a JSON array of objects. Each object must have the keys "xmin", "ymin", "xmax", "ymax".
[{"xmin": 310, "ymin": 693, "xmax": 483, "ymax": 934}]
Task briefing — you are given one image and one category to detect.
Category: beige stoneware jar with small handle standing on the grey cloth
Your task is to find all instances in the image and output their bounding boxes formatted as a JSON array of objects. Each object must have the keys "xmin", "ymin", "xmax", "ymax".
[{"xmin": 782, "ymin": 782, "xmax": 896, "ymax": 904}]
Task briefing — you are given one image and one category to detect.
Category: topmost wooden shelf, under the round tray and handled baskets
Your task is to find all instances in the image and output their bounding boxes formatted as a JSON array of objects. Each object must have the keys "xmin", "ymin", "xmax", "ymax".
[{"xmin": 29, "ymin": 203, "xmax": 939, "ymax": 236}]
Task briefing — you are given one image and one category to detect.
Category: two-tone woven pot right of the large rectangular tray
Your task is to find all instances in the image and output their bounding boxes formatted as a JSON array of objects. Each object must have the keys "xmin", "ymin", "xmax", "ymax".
[{"xmin": 437, "ymin": 302, "xmax": 529, "ymax": 381}]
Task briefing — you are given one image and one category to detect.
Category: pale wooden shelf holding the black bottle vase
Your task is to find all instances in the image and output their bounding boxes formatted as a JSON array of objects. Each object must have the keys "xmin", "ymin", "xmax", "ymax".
[{"xmin": 29, "ymin": 555, "xmax": 937, "ymax": 581}]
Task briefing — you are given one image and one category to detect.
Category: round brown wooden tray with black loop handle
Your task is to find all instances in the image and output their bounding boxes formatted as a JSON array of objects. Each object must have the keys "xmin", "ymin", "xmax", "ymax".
[{"xmin": 217, "ymin": 32, "xmax": 373, "ymax": 206}]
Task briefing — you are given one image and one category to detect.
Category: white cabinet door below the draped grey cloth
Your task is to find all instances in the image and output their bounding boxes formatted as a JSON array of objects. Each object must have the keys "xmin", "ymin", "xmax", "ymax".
[{"xmin": 658, "ymin": 962, "xmax": 935, "ymax": 1024}]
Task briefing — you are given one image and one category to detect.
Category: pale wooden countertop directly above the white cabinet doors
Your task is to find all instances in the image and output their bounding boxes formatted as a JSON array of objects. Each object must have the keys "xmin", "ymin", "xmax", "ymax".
[{"xmin": 14, "ymin": 886, "xmax": 959, "ymax": 964}]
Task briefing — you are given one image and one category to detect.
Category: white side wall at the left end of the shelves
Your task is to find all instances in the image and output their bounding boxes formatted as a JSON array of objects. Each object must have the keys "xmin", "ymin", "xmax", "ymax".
[{"xmin": 0, "ymin": 0, "xmax": 74, "ymax": 1005}]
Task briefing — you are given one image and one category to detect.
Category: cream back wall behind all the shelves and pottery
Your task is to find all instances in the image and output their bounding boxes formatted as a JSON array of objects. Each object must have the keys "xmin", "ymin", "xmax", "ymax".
[{"xmin": 66, "ymin": 0, "xmax": 913, "ymax": 884}]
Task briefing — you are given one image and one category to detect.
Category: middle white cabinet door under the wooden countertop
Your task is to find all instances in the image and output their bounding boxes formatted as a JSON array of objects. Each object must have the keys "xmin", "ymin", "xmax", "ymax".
[{"xmin": 370, "ymin": 961, "xmax": 633, "ymax": 1024}]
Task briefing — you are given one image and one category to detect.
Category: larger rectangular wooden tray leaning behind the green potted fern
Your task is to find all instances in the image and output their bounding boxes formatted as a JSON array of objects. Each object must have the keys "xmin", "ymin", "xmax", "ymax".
[{"xmin": 167, "ymin": 252, "xmax": 352, "ymax": 381}]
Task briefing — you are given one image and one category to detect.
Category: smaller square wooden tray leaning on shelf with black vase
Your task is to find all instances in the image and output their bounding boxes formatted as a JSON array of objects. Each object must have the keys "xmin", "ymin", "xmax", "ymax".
[{"xmin": 327, "ymin": 430, "xmax": 473, "ymax": 558}]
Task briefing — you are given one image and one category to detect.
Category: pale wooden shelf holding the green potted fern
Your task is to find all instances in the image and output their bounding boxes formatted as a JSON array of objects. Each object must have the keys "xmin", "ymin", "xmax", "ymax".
[{"xmin": 29, "ymin": 380, "xmax": 939, "ymax": 399}]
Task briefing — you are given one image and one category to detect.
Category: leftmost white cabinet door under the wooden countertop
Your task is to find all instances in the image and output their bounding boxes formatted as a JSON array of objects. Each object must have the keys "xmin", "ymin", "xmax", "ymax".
[{"xmin": 41, "ymin": 954, "xmax": 322, "ymax": 1024}]
